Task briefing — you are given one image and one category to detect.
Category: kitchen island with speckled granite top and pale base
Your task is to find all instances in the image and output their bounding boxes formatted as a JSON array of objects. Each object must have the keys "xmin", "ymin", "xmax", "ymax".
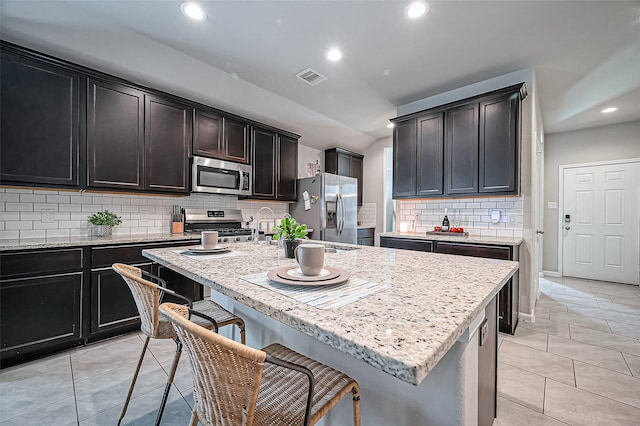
[{"xmin": 143, "ymin": 243, "xmax": 518, "ymax": 425}]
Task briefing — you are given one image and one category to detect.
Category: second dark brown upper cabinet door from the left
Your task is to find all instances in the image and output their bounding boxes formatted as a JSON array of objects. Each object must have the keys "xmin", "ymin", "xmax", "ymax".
[{"xmin": 87, "ymin": 79, "xmax": 144, "ymax": 190}]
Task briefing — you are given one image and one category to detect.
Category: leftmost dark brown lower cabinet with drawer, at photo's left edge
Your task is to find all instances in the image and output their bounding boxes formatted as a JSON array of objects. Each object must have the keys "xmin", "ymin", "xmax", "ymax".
[{"xmin": 0, "ymin": 249, "xmax": 84, "ymax": 367}]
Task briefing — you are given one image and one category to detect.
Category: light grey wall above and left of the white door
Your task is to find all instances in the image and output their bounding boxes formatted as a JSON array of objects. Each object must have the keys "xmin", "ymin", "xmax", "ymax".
[{"xmin": 543, "ymin": 121, "xmax": 640, "ymax": 272}]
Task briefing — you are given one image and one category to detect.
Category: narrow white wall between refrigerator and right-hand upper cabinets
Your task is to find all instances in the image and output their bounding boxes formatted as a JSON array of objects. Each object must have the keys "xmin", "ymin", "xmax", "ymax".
[{"xmin": 362, "ymin": 137, "xmax": 393, "ymax": 241}]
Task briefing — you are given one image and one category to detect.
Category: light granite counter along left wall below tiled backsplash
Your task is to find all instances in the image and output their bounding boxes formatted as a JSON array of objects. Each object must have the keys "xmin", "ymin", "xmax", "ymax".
[{"xmin": 0, "ymin": 233, "xmax": 200, "ymax": 252}]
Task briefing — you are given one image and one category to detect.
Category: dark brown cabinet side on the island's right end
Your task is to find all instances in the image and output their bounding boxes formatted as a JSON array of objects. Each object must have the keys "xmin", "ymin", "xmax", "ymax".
[{"xmin": 478, "ymin": 298, "xmax": 498, "ymax": 426}]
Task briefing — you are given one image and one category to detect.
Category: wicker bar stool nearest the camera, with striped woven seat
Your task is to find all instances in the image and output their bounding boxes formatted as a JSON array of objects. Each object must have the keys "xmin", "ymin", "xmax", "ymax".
[{"xmin": 160, "ymin": 303, "xmax": 360, "ymax": 426}]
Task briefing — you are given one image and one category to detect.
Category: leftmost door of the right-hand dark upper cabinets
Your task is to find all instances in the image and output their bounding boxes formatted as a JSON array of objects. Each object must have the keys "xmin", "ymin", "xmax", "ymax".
[{"xmin": 393, "ymin": 118, "xmax": 417, "ymax": 198}]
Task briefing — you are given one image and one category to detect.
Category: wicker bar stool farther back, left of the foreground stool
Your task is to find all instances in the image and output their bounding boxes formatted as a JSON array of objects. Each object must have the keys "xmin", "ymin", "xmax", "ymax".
[{"xmin": 112, "ymin": 263, "xmax": 245, "ymax": 425}]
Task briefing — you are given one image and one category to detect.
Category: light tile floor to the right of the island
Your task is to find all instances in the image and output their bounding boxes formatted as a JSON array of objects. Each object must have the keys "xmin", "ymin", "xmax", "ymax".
[{"xmin": 494, "ymin": 278, "xmax": 640, "ymax": 426}]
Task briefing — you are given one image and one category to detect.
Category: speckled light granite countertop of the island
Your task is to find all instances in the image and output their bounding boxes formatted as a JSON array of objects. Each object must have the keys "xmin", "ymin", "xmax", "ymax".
[{"xmin": 143, "ymin": 243, "xmax": 518, "ymax": 385}]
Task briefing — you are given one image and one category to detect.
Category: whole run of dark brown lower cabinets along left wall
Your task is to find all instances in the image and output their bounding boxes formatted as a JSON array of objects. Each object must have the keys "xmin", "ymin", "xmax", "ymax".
[{"xmin": 0, "ymin": 240, "xmax": 203, "ymax": 368}]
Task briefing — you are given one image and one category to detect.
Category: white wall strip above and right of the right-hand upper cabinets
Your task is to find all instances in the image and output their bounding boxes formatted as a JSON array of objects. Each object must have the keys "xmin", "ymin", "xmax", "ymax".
[{"xmin": 397, "ymin": 68, "xmax": 542, "ymax": 317}]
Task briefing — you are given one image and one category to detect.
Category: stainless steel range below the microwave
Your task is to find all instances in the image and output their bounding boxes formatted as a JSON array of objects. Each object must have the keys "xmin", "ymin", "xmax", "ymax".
[{"xmin": 184, "ymin": 209, "xmax": 252, "ymax": 243}]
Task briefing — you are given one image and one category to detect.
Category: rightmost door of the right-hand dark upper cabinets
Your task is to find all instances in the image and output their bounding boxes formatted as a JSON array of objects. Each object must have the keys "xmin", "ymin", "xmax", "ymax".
[{"xmin": 478, "ymin": 93, "xmax": 520, "ymax": 193}]
